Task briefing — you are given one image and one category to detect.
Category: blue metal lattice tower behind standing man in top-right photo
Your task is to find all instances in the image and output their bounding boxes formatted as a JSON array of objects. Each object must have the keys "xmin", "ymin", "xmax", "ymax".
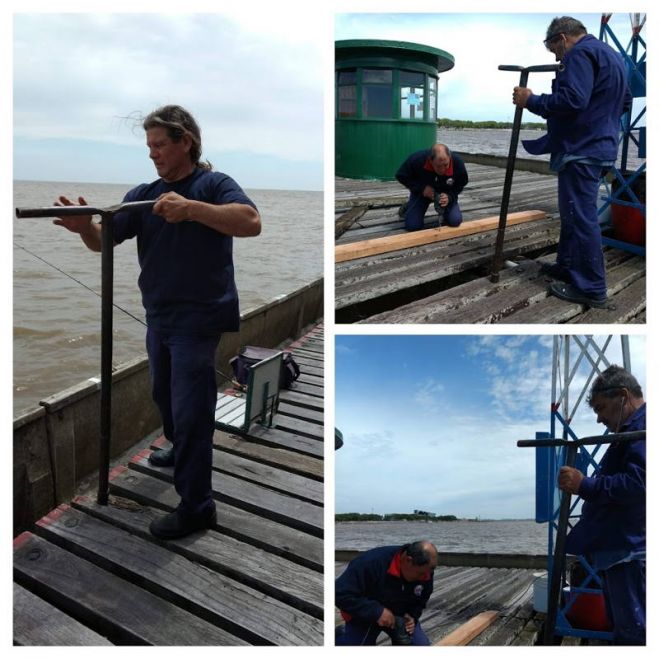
[{"xmin": 598, "ymin": 14, "xmax": 647, "ymax": 256}]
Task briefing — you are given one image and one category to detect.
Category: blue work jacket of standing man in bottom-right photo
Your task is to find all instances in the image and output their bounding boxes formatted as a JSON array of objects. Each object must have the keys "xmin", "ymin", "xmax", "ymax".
[{"xmin": 566, "ymin": 404, "xmax": 645, "ymax": 554}]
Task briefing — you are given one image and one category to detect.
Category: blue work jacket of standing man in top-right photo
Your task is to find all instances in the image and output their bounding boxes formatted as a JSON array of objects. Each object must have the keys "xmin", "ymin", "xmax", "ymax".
[{"xmin": 523, "ymin": 34, "xmax": 632, "ymax": 160}]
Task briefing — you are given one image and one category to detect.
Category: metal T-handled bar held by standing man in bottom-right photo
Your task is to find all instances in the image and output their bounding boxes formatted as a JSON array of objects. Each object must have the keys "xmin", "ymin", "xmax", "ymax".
[{"xmin": 517, "ymin": 430, "xmax": 645, "ymax": 645}]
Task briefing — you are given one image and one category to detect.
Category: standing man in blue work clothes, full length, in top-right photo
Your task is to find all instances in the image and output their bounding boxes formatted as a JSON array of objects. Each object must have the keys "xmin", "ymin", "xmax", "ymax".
[{"xmin": 513, "ymin": 16, "xmax": 632, "ymax": 308}]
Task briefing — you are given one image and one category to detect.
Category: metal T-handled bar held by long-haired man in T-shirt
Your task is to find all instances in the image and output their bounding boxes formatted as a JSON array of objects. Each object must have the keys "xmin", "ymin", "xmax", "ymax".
[{"xmin": 16, "ymin": 200, "xmax": 156, "ymax": 506}]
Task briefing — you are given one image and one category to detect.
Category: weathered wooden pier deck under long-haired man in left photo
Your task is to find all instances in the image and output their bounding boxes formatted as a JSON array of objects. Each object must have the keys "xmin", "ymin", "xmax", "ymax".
[{"xmin": 14, "ymin": 326, "xmax": 323, "ymax": 646}]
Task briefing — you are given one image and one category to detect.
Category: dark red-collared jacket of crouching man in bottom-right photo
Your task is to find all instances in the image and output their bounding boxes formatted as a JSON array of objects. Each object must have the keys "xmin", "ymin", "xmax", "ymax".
[{"xmin": 336, "ymin": 546, "xmax": 433, "ymax": 623}]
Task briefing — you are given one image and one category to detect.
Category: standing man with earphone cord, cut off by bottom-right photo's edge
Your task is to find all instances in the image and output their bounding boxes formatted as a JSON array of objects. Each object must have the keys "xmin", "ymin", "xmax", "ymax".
[{"xmin": 558, "ymin": 366, "xmax": 646, "ymax": 645}]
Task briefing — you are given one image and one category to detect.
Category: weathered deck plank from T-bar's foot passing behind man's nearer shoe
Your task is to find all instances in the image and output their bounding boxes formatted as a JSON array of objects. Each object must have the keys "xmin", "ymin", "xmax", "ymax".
[{"xmin": 110, "ymin": 467, "xmax": 323, "ymax": 571}]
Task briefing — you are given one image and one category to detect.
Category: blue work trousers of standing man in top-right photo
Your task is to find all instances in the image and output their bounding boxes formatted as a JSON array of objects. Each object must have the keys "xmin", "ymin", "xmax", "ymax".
[{"xmin": 556, "ymin": 162, "xmax": 606, "ymax": 298}]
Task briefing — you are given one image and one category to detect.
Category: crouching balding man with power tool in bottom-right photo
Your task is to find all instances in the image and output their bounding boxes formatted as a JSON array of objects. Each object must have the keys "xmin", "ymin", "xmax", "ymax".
[{"xmin": 335, "ymin": 540, "xmax": 437, "ymax": 645}]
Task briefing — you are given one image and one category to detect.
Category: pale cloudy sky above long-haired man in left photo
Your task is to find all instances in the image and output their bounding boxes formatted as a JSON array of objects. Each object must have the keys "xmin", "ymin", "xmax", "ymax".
[{"xmin": 12, "ymin": 8, "xmax": 324, "ymax": 190}]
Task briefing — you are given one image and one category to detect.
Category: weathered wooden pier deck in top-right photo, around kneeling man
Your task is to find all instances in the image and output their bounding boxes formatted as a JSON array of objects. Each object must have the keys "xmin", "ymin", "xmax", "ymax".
[{"xmin": 335, "ymin": 164, "xmax": 646, "ymax": 323}]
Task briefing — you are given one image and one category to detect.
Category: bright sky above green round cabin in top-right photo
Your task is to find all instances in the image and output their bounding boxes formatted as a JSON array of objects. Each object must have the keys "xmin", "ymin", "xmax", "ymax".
[{"xmin": 335, "ymin": 11, "xmax": 644, "ymax": 121}]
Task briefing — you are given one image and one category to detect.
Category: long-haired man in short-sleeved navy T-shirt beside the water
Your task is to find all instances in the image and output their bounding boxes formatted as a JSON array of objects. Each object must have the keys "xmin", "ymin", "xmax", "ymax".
[{"xmin": 55, "ymin": 105, "xmax": 261, "ymax": 539}]
